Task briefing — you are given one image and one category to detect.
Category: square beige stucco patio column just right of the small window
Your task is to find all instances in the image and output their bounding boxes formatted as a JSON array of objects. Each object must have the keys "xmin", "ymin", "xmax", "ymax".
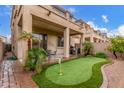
[{"xmin": 64, "ymin": 27, "xmax": 70, "ymax": 58}]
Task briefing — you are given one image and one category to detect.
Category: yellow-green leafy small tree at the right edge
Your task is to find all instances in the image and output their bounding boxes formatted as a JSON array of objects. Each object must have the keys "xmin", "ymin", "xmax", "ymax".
[{"xmin": 108, "ymin": 37, "xmax": 124, "ymax": 59}]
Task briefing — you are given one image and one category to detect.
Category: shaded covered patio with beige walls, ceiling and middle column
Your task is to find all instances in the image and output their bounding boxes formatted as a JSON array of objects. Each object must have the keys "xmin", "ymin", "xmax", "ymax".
[{"xmin": 32, "ymin": 15, "xmax": 83, "ymax": 59}]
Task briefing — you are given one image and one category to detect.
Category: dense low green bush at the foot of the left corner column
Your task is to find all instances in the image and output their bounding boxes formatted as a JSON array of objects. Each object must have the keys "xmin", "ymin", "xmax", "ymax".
[{"xmin": 24, "ymin": 48, "xmax": 47, "ymax": 73}]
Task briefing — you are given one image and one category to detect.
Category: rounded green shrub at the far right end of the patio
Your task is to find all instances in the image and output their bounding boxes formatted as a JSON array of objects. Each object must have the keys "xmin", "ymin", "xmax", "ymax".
[{"xmin": 83, "ymin": 41, "xmax": 93, "ymax": 56}]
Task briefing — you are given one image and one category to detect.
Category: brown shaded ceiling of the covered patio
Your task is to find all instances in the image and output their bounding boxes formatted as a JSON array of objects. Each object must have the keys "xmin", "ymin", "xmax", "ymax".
[{"xmin": 32, "ymin": 16, "xmax": 82, "ymax": 35}]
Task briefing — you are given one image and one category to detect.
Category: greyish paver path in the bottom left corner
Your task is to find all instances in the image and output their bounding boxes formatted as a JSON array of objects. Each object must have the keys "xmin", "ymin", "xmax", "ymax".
[{"xmin": 0, "ymin": 61, "xmax": 20, "ymax": 88}]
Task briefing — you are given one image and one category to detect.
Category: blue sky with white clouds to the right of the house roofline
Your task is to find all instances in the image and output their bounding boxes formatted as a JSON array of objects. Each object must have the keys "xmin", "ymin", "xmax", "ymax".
[{"xmin": 63, "ymin": 5, "xmax": 124, "ymax": 36}]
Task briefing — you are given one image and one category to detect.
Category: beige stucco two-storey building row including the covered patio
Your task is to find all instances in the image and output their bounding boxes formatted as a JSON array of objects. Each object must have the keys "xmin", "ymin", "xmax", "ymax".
[{"xmin": 11, "ymin": 5, "xmax": 107, "ymax": 63}]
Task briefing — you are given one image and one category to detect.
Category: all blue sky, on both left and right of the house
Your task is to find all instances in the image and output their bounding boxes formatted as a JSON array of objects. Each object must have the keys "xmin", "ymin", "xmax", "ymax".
[{"xmin": 0, "ymin": 5, "xmax": 124, "ymax": 36}]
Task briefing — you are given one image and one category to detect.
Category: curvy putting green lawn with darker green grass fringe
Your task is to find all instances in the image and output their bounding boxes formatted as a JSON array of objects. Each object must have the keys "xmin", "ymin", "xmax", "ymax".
[{"xmin": 33, "ymin": 57, "xmax": 108, "ymax": 88}]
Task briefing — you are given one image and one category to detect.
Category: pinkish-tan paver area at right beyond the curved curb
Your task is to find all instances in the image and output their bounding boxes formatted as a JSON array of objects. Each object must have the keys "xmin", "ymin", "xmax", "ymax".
[{"xmin": 104, "ymin": 60, "xmax": 124, "ymax": 88}]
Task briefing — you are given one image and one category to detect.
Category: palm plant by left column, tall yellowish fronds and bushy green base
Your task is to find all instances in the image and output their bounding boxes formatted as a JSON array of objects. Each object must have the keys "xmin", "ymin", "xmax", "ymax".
[{"xmin": 19, "ymin": 31, "xmax": 47, "ymax": 73}]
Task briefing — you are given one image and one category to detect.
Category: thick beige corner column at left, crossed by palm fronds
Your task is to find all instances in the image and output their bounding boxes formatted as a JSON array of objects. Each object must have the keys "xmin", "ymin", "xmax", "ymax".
[{"xmin": 22, "ymin": 6, "xmax": 32, "ymax": 62}]
